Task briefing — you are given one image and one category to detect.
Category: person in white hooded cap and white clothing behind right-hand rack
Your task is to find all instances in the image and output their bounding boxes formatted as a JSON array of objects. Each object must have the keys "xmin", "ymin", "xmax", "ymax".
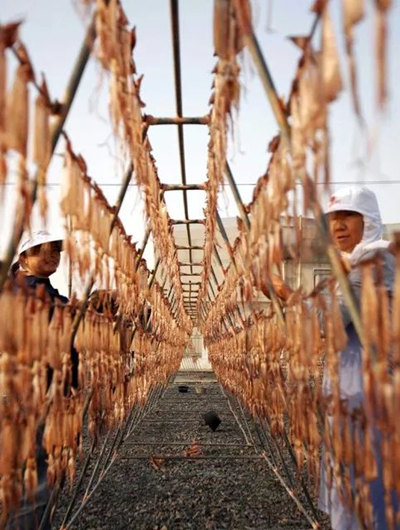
[{"xmin": 265, "ymin": 187, "xmax": 399, "ymax": 530}]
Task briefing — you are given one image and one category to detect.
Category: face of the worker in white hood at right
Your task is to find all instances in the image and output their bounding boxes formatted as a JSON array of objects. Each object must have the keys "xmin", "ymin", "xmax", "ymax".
[{"xmin": 328, "ymin": 210, "xmax": 364, "ymax": 252}]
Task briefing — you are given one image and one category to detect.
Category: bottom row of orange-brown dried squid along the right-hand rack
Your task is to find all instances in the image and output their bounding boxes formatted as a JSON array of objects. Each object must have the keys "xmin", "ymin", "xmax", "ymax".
[{"xmin": 206, "ymin": 248, "xmax": 400, "ymax": 526}]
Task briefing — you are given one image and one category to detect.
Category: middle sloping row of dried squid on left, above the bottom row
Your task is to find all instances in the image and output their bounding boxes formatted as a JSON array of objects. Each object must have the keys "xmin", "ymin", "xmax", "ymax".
[{"xmin": 58, "ymin": 135, "xmax": 190, "ymax": 408}]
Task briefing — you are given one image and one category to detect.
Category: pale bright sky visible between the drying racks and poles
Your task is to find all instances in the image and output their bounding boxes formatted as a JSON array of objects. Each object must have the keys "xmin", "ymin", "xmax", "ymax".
[{"xmin": 1, "ymin": 0, "xmax": 400, "ymax": 288}]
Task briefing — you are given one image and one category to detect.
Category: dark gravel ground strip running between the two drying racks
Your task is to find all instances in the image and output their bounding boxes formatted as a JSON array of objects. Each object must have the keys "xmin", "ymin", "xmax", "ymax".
[{"xmin": 54, "ymin": 375, "xmax": 329, "ymax": 530}]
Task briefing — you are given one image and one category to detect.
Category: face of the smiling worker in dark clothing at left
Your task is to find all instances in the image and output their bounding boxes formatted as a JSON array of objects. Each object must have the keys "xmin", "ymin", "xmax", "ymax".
[{"xmin": 20, "ymin": 241, "xmax": 62, "ymax": 278}]
